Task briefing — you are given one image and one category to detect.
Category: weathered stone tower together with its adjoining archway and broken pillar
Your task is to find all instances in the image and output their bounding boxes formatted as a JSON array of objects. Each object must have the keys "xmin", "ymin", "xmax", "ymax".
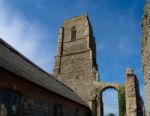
[{"xmin": 53, "ymin": 15, "xmax": 143, "ymax": 116}]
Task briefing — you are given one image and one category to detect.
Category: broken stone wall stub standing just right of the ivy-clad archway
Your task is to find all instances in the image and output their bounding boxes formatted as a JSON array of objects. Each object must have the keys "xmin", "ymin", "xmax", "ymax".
[{"xmin": 125, "ymin": 68, "xmax": 144, "ymax": 116}]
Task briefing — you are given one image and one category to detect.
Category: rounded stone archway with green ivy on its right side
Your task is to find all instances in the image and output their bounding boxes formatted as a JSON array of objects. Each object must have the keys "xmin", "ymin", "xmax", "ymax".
[{"xmin": 95, "ymin": 82, "xmax": 125, "ymax": 116}]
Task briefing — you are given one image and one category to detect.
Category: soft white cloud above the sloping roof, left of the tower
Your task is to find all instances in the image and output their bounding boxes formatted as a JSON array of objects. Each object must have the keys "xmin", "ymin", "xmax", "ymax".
[{"xmin": 0, "ymin": 1, "xmax": 55, "ymax": 71}]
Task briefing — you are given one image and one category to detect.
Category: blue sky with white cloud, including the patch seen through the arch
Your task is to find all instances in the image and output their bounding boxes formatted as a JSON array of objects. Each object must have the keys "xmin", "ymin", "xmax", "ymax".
[{"xmin": 0, "ymin": 0, "xmax": 146, "ymax": 115}]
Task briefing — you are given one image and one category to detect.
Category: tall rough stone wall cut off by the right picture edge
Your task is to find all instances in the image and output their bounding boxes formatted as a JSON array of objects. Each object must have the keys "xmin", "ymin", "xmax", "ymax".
[{"xmin": 142, "ymin": 0, "xmax": 150, "ymax": 116}]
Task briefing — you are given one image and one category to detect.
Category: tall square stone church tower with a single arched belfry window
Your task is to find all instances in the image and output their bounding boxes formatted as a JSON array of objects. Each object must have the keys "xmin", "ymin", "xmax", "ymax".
[{"xmin": 53, "ymin": 15, "xmax": 98, "ymax": 107}]
